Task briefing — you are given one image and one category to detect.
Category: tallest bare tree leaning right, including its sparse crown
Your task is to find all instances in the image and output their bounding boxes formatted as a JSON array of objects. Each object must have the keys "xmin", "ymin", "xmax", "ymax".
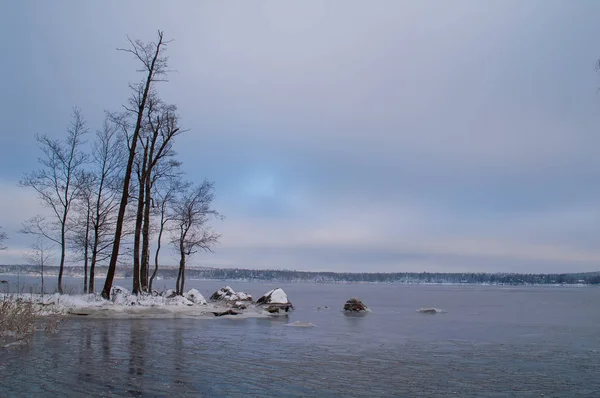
[{"xmin": 102, "ymin": 31, "xmax": 168, "ymax": 299}]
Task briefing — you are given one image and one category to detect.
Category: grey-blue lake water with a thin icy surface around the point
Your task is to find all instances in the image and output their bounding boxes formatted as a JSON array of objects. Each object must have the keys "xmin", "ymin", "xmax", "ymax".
[{"xmin": 0, "ymin": 280, "xmax": 600, "ymax": 397}]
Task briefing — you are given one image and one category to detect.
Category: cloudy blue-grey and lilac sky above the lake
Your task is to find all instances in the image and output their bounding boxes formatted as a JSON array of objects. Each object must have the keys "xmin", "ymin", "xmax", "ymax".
[{"xmin": 0, "ymin": 0, "xmax": 600, "ymax": 273}]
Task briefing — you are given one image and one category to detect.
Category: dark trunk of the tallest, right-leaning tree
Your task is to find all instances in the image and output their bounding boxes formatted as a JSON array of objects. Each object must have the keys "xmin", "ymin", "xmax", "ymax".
[{"xmin": 102, "ymin": 33, "xmax": 162, "ymax": 300}]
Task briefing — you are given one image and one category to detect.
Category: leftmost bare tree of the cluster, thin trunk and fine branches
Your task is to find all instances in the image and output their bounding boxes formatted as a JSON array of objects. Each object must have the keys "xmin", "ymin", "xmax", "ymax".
[{"xmin": 19, "ymin": 108, "xmax": 87, "ymax": 294}]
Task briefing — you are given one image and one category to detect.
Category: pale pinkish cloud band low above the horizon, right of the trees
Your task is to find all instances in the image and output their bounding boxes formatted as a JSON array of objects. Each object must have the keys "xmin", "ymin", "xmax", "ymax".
[{"xmin": 212, "ymin": 202, "xmax": 600, "ymax": 272}]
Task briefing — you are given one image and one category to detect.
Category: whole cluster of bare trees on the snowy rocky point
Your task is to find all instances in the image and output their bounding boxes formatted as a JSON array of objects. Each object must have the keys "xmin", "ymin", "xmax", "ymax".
[{"xmin": 20, "ymin": 31, "xmax": 221, "ymax": 299}]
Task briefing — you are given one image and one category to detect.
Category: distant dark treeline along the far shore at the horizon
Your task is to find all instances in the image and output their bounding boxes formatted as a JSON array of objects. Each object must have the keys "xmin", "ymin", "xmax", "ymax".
[{"xmin": 0, "ymin": 265, "xmax": 600, "ymax": 285}]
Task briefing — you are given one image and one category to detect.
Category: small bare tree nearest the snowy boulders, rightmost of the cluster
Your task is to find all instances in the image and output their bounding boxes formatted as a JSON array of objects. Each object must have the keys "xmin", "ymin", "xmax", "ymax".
[{"xmin": 171, "ymin": 180, "xmax": 223, "ymax": 295}]
